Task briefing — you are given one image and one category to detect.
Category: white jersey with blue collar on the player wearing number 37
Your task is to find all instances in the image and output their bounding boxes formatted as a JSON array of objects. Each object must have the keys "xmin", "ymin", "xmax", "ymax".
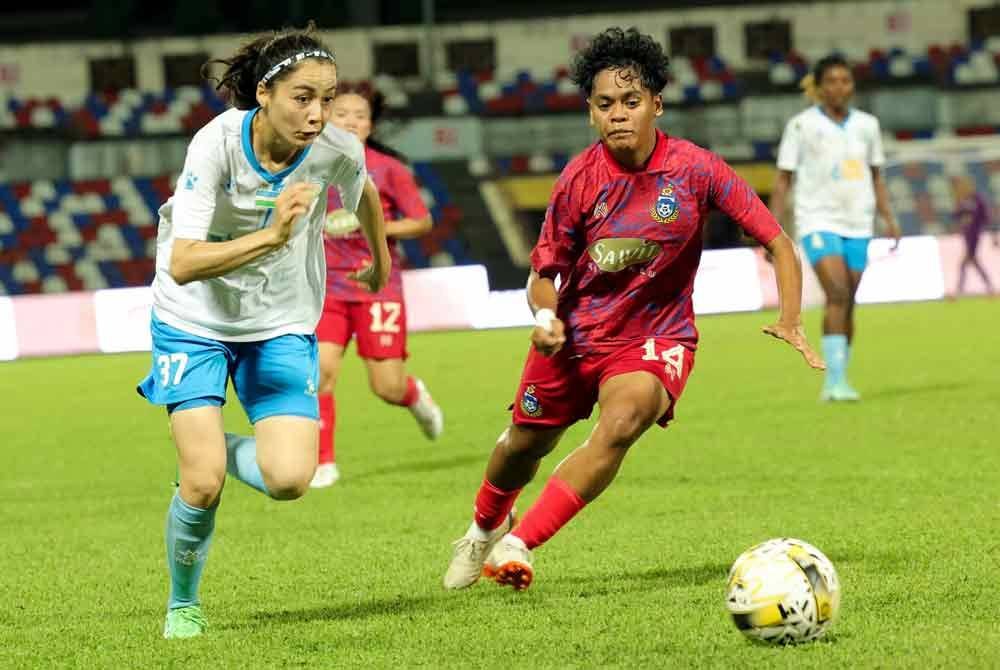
[{"xmin": 153, "ymin": 109, "xmax": 367, "ymax": 342}]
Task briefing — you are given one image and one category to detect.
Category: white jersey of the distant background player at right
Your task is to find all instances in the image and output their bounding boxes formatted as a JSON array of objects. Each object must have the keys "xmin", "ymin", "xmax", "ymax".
[{"xmin": 778, "ymin": 106, "xmax": 885, "ymax": 239}]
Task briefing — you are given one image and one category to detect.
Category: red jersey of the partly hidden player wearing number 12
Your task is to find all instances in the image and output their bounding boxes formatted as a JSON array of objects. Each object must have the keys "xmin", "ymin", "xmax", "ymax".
[{"xmin": 324, "ymin": 146, "xmax": 427, "ymax": 302}]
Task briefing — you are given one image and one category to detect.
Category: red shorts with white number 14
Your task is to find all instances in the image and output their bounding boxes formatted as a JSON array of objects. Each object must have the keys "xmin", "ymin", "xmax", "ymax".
[{"xmin": 513, "ymin": 337, "xmax": 694, "ymax": 428}]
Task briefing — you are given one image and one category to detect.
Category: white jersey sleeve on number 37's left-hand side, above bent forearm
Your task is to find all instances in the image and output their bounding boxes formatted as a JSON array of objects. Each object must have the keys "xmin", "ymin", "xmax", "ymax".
[{"xmin": 171, "ymin": 125, "xmax": 226, "ymax": 241}]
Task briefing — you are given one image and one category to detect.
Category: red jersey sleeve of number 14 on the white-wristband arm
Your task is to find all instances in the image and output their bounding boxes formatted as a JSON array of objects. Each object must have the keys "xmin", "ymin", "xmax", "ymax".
[{"xmin": 531, "ymin": 172, "xmax": 583, "ymax": 281}]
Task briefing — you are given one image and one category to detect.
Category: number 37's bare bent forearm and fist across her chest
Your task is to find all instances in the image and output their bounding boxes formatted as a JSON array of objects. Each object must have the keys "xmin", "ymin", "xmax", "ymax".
[{"xmin": 170, "ymin": 184, "xmax": 317, "ymax": 285}]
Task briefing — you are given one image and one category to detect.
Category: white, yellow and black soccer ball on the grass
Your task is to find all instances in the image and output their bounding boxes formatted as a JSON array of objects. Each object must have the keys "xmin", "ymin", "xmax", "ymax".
[{"xmin": 726, "ymin": 537, "xmax": 840, "ymax": 644}]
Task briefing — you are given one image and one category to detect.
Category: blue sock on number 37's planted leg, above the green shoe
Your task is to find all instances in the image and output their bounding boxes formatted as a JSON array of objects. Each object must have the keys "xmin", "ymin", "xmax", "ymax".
[{"xmin": 167, "ymin": 493, "xmax": 219, "ymax": 609}]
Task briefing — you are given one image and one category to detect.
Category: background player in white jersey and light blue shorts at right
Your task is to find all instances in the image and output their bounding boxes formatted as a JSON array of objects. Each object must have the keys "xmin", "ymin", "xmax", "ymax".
[{"xmin": 770, "ymin": 56, "xmax": 900, "ymax": 400}]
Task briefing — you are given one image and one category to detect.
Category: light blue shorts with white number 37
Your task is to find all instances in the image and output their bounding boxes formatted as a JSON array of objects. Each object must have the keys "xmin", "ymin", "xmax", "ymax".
[{"xmin": 136, "ymin": 316, "xmax": 319, "ymax": 423}]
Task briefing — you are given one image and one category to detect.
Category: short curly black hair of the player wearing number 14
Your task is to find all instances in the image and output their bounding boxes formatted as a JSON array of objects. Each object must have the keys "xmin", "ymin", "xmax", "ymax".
[{"xmin": 570, "ymin": 27, "xmax": 670, "ymax": 96}]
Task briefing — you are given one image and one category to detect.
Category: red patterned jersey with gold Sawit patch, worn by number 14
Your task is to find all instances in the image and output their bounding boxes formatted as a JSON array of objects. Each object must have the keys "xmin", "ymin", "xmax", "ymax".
[{"xmin": 531, "ymin": 131, "xmax": 781, "ymax": 354}]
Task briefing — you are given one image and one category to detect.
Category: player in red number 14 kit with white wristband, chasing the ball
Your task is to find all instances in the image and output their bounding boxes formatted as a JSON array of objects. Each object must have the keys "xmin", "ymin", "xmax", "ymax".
[{"xmin": 444, "ymin": 28, "xmax": 824, "ymax": 589}]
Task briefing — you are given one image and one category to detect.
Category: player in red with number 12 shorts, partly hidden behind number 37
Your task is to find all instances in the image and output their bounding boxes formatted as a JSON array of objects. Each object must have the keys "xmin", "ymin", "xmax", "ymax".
[{"xmin": 312, "ymin": 92, "xmax": 443, "ymax": 488}]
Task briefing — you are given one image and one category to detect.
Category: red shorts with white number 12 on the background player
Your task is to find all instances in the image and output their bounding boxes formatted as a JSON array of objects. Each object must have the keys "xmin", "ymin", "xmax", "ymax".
[{"xmin": 316, "ymin": 298, "xmax": 409, "ymax": 360}]
